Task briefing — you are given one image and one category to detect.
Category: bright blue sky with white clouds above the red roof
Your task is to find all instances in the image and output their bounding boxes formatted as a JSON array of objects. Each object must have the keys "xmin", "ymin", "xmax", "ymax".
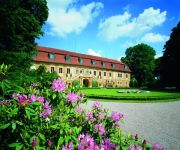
[{"xmin": 36, "ymin": 0, "xmax": 180, "ymax": 60}]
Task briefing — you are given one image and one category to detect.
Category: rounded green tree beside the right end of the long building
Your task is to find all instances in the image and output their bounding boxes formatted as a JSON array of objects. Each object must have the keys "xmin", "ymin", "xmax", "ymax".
[{"xmin": 121, "ymin": 43, "xmax": 155, "ymax": 86}]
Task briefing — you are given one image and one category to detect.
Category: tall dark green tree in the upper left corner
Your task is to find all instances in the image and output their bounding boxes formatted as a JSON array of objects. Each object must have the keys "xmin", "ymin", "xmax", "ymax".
[{"xmin": 0, "ymin": 0, "xmax": 48, "ymax": 68}]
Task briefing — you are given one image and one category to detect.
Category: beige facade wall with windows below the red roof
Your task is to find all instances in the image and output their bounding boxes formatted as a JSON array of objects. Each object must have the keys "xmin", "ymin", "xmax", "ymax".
[{"xmin": 34, "ymin": 63, "xmax": 130, "ymax": 87}]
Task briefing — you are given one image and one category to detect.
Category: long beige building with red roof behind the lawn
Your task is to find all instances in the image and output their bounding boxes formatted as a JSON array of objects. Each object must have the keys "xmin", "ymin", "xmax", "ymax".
[{"xmin": 33, "ymin": 46, "xmax": 131, "ymax": 87}]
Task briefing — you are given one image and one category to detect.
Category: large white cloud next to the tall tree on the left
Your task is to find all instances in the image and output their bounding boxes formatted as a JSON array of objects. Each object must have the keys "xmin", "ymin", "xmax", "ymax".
[{"xmin": 47, "ymin": 0, "xmax": 103, "ymax": 37}]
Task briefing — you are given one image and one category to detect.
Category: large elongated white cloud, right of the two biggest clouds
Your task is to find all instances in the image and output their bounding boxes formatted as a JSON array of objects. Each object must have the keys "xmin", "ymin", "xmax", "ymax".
[{"xmin": 99, "ymin": 7, "xmax": 166, "ymax": 41}]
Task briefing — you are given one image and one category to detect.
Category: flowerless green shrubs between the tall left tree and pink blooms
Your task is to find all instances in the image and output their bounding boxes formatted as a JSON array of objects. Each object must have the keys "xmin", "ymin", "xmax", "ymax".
[{"xmin": 0, "ymin": 64, "xmax": 58, "ymax": 99}]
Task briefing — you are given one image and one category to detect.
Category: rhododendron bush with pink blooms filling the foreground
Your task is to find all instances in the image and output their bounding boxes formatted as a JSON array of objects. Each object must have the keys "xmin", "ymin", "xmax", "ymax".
[{"xmin": 0, "ymin": 78, "xmax": 163, "ymax": 150}]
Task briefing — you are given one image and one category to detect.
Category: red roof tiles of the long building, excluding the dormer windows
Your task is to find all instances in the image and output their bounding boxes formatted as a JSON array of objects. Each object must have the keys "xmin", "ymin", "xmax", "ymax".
[{"xmin": 34, "ymin": 46, "xmax": 130, "ymax": 72}]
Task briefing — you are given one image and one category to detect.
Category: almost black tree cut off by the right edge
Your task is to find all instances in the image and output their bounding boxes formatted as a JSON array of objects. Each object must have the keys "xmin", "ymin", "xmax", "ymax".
[{"xmin": 160, "ymin": 22, "xmax": 180, "ymax": 88}]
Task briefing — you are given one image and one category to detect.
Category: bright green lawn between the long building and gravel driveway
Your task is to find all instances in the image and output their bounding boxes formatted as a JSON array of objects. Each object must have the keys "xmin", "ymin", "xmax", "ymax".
[{"xmin": 80, "ymin": 88, "xmax": 180, "ymax": 100}]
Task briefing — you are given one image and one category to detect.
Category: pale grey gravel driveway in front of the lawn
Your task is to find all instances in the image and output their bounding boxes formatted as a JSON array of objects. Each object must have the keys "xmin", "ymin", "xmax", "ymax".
[{"xmin": 82, "ymin": 101, "xmax": 180, "ymax": 150}]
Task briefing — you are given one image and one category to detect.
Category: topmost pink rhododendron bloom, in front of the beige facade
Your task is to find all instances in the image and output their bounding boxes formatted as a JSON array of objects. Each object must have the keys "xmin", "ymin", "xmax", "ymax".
[{"xmin": 52, "ymin": 78, "xmax": 66, "ymax": 92}]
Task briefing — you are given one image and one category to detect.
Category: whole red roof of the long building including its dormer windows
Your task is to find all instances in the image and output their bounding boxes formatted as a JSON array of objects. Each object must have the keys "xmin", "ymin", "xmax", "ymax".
[{"xmin": 34, "ymin": 47, "xmax": 130, "ymax": 72}]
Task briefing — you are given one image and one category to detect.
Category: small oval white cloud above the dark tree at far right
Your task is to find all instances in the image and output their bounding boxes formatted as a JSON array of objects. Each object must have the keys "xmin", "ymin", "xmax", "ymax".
[{"xmin": 141, "ymin": 33, "xmax": 169, "ymax": 43}]
